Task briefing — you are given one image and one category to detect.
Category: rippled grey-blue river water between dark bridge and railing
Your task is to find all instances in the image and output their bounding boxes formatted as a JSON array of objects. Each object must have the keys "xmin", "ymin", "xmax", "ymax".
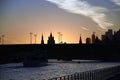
[{"xmin": 0, "ymin": 61, "xmax": 120, "ymax": 80}]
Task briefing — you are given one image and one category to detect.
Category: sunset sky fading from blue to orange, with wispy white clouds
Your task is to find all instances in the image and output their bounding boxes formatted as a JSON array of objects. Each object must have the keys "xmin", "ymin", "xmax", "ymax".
[{"xmin": 0, "ymin": 0, "xmax": 120, "ymax": 44}]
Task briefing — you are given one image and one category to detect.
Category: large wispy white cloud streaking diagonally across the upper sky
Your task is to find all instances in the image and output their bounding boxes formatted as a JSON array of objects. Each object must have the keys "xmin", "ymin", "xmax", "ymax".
[{"xmin": 46, "ymin": 0, "xmax": 113, "ymax": 29}]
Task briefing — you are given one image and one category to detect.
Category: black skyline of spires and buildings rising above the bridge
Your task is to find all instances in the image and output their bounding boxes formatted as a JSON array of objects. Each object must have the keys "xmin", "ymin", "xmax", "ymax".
[{"xmin": 38, "ymin": 29, "xmax": 120, "ymax": 44}]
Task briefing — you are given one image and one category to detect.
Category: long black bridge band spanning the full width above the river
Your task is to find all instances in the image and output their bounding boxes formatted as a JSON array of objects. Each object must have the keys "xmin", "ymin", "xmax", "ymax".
[{"xmin": 0, "ymin": 44, "xmax": 120, "ymax": 63}]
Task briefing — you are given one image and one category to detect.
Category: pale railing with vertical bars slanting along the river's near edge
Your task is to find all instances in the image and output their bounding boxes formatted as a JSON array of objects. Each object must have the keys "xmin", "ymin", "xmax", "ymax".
[{"xmin": 43, "ymin": 66, "xmax": 120, "ymax": 80}]
